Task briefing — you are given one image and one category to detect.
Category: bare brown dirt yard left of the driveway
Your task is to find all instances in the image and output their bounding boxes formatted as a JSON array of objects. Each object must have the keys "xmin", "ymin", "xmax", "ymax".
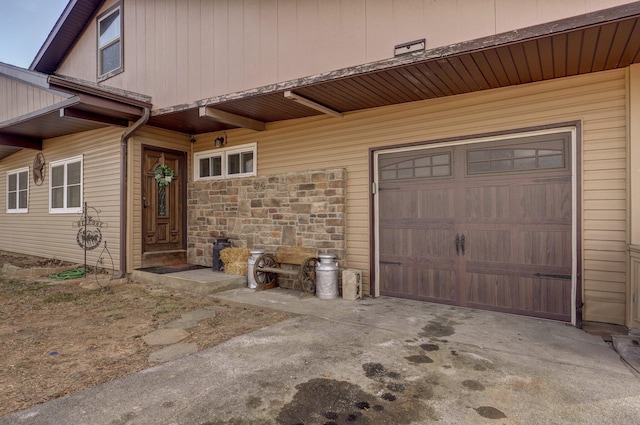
[{"xmin": 0, "ymin": 251, "xmax": 291, "ymax": 416}]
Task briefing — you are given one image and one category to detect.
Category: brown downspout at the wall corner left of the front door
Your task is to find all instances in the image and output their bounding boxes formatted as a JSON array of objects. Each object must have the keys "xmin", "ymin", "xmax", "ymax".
[{"xmin": 117, "ymin": 107, "xmax": 151, "ymax": 279}]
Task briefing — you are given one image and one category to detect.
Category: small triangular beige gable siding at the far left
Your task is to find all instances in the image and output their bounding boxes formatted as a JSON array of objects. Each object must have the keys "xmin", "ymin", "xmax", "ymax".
[{"xmin": 0, "ymin": 76, "xmax": 64, "ymax": 122}]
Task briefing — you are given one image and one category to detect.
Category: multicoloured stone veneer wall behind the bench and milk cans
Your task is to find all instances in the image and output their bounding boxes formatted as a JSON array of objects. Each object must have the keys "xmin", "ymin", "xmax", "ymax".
[{"xmin": 187, "ymin": 169, "xmax": 347, "ymax": 267}]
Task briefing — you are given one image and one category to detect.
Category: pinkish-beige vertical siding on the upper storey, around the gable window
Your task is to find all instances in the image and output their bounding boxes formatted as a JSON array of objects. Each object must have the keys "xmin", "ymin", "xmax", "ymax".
[{"xmin": 58, "ymin": 0, "xmax": 630, "ymax": 108}]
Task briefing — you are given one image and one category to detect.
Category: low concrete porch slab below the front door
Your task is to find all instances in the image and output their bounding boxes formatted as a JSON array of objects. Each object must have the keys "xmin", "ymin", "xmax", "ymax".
[{"xmin": 131, "ymin": 269, "xmax": 247, "ymax": 295}]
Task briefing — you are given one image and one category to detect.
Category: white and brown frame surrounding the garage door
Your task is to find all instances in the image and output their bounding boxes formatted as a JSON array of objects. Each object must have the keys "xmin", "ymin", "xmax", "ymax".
[{"xmin": 369, "ymin": 121, "xmax": 582, "ymax": 328}]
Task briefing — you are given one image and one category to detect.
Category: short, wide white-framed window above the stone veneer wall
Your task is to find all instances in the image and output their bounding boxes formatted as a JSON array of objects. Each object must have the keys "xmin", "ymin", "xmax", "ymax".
[{"xmin": 194, "ymin": 143, "xmax": 256, "ymax": 180}]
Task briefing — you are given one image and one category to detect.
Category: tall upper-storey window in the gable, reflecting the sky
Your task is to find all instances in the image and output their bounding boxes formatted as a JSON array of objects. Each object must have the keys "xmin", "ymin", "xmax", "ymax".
[{"xmin": 98, "ymin": 5, "xmax": 122, "ymax": 81}]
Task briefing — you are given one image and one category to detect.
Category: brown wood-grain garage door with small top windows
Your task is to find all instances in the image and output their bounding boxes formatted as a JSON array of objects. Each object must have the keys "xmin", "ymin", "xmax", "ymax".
[{"xmin": 378, "ymin": 133, "xmax": 572, "ymax": 321}]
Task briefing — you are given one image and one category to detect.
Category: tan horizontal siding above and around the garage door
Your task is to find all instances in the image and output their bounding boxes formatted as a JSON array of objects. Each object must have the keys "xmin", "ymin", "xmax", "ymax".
[{"xmin": 195, "ymin": 70, "xmax": 627, "ymax": 323}]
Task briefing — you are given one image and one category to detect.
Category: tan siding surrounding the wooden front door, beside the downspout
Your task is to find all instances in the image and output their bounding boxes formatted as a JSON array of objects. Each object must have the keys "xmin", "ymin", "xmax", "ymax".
[{"xmin": 127, "ymin": 127, "xmax": 192, "ymax": 271}]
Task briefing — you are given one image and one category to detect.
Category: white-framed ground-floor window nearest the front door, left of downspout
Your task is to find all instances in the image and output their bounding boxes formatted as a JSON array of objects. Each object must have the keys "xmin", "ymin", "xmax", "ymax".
[{"xmin": 49, "ymin": 156, "xmax": 82, "ymax": 213}]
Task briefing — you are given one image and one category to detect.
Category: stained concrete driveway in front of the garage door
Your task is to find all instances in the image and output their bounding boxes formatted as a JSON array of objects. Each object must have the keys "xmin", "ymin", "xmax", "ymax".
[{"xmin": 0, "ymin": 289, "xmax": 640, "ymax": 425}]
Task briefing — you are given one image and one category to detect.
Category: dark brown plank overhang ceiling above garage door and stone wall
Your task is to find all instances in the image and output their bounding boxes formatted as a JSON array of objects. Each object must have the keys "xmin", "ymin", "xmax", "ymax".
[{"xmin": 149, "ymin": 2, "xmax": 640, "ymax": 134}]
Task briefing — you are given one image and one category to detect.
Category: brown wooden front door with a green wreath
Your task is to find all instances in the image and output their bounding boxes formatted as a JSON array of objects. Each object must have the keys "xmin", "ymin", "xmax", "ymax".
[{"xmin": 142, "ymin": 147, "xmax": 186, "ymax": 254}]
